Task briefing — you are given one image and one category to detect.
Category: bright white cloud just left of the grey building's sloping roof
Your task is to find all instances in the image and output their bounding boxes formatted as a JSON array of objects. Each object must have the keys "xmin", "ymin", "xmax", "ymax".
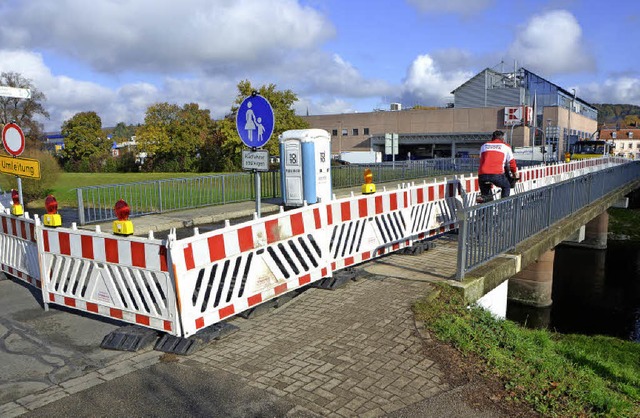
[{"xmin": 401, "ymin": 54, "xmax": 474, "ymax": 106}]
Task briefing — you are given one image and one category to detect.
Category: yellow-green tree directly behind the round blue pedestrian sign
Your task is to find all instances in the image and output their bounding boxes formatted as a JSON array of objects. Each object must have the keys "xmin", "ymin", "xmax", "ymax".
[{"xmin": 218, "ymin": 80, "xmax": 309, "ymax": 169}]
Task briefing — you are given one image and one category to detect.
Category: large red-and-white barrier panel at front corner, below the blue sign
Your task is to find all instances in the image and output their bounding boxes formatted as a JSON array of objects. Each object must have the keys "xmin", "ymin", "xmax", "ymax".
[{"xmin": 171, "ymin": 204, "xmax": 331, "ymax": 336}]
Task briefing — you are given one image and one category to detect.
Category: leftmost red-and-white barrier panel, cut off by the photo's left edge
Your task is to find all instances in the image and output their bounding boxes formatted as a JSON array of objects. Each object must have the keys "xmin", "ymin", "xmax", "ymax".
[{"xmin": 0, "ymin": 209, "xmax": 41, "ymax": 288}]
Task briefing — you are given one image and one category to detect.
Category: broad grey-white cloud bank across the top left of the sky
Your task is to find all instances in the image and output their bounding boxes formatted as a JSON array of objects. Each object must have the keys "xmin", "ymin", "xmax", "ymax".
[{"xmin": 0, "ymin": 0, "xmax": 335, "ymax": 73}]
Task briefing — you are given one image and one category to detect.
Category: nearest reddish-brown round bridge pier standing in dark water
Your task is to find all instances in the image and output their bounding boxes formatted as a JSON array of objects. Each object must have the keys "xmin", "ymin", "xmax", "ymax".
[{"xmin": 508, "ymin": 249, "xmax": 555, "ymax": 308}]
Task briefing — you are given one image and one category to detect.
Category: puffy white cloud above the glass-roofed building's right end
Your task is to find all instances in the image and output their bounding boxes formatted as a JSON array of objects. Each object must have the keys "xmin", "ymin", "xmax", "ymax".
[{"xmin": 509, "ymin": 10, "xmax": 595, "ymax": 76}]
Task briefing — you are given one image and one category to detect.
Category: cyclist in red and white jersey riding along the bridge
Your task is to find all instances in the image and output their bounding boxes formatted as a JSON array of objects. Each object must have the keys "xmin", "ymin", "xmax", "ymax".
[{"xmin": 478, "ymin": 131, "xmax": 518, "ymax": 200}]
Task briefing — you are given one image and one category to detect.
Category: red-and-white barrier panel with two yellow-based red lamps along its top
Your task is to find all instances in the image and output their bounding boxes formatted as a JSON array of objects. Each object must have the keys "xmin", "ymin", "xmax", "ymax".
[{"xmin": 37, "ymin": 226, "xmax": 181, "ymax": 334}]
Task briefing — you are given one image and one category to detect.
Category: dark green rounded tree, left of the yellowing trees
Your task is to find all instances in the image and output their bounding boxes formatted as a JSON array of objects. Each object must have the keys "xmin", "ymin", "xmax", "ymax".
[{"xmin": 62, "ymin": 112, "xmax": 111, "ymax": 172}]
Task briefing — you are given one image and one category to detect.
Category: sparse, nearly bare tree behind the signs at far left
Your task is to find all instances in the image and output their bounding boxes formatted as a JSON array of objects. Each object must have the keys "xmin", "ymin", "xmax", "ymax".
[{"xmin": 0, "ymin": 72, "xmax": 49, "ymax": 141}]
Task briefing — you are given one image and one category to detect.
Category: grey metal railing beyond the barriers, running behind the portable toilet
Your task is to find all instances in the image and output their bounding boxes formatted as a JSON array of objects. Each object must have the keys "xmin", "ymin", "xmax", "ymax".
[{"xmin": 76, "ymin": 158, "xmax": 490, "ymax": 225}]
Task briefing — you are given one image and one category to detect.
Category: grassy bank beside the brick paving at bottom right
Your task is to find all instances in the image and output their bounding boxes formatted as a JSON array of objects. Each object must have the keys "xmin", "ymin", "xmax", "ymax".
[{"xmin": 414, "ymin": 286, "xmax": 640, "ymax": 417}]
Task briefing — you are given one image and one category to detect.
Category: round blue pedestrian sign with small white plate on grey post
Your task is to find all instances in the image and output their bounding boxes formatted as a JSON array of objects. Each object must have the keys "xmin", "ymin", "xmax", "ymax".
[{"xmin": 236, "ymin": 91, "xmax": 275, "ymax": 217}]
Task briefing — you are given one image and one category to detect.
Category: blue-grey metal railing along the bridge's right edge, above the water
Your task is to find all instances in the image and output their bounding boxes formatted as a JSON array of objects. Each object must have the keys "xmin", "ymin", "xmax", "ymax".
[{"xmin": 456, "ymin": 162, "xmax": 640, "ymax": 280}]
